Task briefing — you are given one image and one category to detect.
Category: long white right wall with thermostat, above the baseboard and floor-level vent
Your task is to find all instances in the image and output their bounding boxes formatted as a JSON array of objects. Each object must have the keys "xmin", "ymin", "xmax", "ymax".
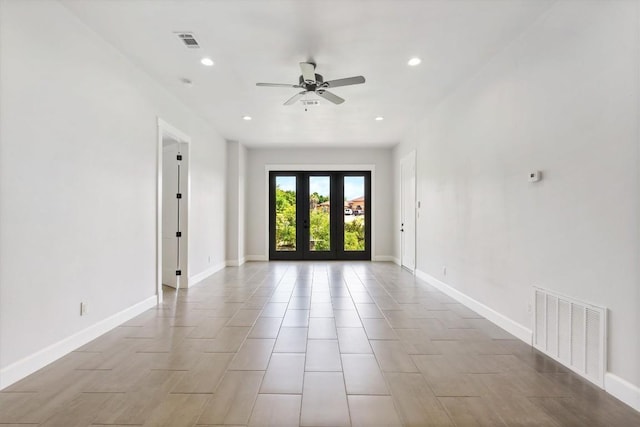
[{"xmin": 394, "ymin": 1, "xmax": 640, "ymax": 408}]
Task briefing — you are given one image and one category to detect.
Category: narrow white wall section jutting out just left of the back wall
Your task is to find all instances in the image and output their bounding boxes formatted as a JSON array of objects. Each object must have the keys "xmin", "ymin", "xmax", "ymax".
[{"xmin": 226, "ymin": 141, "xmax": 247, "ymax": 265}]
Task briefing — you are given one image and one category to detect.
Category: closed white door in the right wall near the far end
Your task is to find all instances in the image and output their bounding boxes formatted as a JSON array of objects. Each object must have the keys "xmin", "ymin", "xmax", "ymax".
[{"xmin": 400, "ymin": 151, "xmax": 416, "ymax": 271}]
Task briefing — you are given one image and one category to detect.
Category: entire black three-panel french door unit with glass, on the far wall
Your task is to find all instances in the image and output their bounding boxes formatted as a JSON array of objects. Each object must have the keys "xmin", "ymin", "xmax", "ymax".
[{"xmin": 269, "ymin": 171, "xmax": 371, "ymax": 260}]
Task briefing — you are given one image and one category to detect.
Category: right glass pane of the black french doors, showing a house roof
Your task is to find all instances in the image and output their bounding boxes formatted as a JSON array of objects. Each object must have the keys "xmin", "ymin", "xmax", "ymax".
[{"xmin": 343, "ymin": 176, "xmax": 367, "ymax": 251}]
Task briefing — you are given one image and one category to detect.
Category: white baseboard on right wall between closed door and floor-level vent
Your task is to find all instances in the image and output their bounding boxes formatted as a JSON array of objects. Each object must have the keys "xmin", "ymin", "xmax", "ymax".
[{"xmin": 415, "ymin": 269, "xmax": 533, "ymax": 345}]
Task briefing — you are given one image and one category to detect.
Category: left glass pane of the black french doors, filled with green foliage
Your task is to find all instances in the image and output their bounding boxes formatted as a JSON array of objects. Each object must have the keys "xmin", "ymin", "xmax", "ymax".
[{"xmin": 275, "ymin": 176, "xmax": 297, "ymax": 252}]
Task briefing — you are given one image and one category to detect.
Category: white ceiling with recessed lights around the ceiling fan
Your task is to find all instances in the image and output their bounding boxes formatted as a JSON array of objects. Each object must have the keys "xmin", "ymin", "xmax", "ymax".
[{"xmin": 62, "ymin": 0, "xmax": 552, "ymax": 147}]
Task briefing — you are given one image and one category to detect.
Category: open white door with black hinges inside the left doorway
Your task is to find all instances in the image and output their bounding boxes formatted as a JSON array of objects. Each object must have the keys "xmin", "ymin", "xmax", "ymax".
[{"xmin": 162, "ymin": 140, "xmax": 183, "ymax": 288}]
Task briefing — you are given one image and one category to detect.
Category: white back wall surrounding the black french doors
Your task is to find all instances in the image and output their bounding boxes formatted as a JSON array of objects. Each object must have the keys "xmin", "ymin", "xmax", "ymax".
[{"xmin": 246, "ymin": 148, "xmax": 394, "ymax": 260}]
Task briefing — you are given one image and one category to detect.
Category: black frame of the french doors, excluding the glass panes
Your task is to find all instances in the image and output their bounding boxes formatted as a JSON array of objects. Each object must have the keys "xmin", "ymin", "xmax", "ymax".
[{"xmin": 269, "ymin": 170, "xmax": 372, "ymax": 260}]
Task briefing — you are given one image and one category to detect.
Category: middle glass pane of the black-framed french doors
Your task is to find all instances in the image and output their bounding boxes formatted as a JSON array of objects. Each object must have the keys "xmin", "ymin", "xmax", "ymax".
[{"xmin": 309, "ymin": 176, "xmax": 331, "ymax": 252}]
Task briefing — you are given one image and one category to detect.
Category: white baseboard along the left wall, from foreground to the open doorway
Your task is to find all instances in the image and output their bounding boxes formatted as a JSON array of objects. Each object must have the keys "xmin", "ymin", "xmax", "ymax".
[{"xmin": 0, "ymin": 295, "xmax": 157, "ymax": 390}]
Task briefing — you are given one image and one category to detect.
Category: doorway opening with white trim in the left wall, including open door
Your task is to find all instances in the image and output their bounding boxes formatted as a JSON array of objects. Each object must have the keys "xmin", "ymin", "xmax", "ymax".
[{"xmin": 156, "ymin": 119, "xmax": 190, "ymax": 303}]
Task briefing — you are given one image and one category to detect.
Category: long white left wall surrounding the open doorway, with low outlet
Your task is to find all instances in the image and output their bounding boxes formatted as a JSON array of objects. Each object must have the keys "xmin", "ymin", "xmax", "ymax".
[{"xmin": 0, "ymin": 0, "xmax": 225, "ymax": 387}]
